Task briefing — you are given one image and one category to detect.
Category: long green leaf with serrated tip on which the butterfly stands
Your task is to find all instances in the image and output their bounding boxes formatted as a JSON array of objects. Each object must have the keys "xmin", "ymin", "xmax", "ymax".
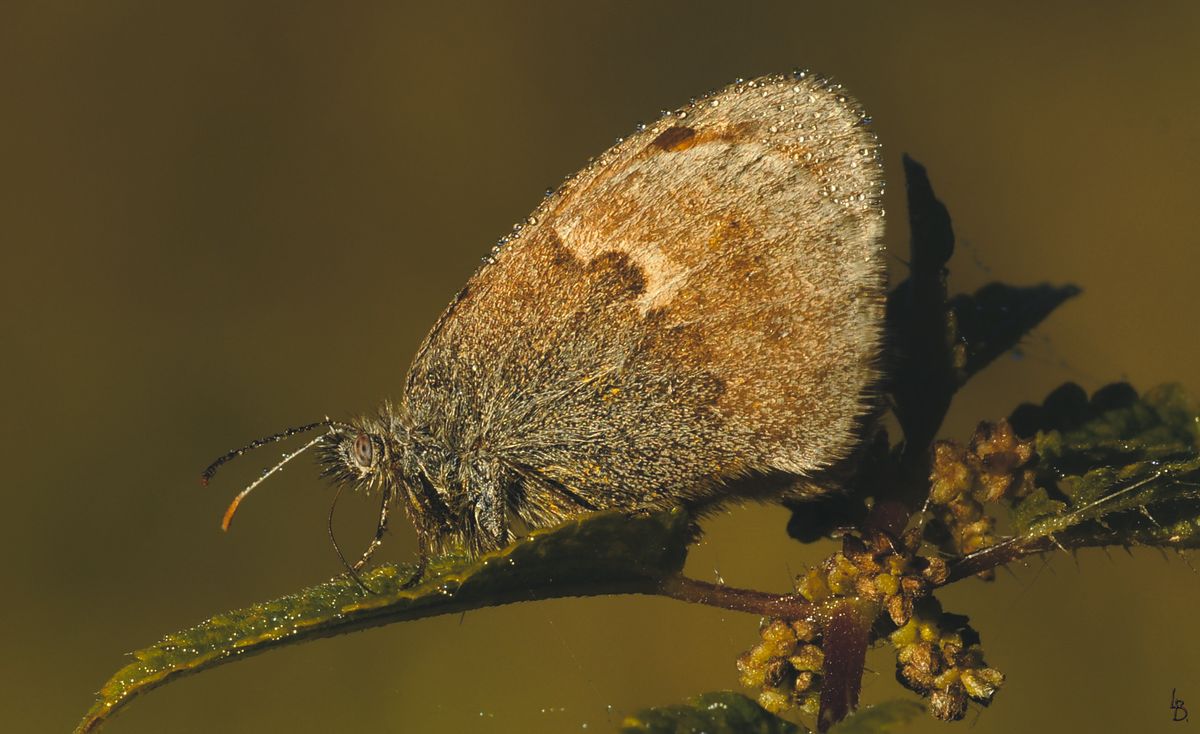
[{"xmin": 77, "ymin": 511, "xmax": 695, "ymax": 733}]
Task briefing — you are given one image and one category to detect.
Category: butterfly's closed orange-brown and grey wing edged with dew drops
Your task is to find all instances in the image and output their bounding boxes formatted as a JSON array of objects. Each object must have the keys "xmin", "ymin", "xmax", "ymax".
[{"xmin": 402, "ymin": 76, "xmax": 884, "ymax": 524}]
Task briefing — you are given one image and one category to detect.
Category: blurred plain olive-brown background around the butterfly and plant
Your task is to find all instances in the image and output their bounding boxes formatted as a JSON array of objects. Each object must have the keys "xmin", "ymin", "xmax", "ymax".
[{"xmin": 0, "ymin": 1, "xmax": 1200, "ymax": 734}]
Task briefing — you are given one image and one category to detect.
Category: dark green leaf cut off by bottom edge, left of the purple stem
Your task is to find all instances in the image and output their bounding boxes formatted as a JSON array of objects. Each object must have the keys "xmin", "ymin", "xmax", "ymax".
[{"xmin": 620, "ymin": 691, "xmax": 808, "ymax": 734}]
